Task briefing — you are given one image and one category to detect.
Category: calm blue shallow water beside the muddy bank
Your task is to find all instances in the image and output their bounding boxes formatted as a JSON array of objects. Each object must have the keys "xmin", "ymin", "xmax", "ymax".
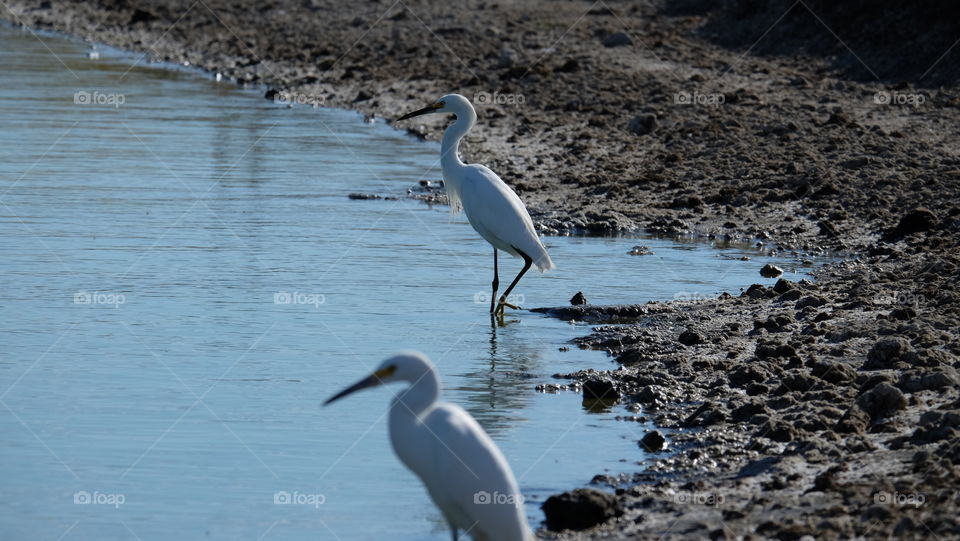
[{"xmin": 0, "ymin": 27, "xmax": 824, "ymax": 540}]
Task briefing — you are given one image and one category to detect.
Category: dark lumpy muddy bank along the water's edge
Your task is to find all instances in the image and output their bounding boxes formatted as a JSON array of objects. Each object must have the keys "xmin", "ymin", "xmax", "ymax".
[{"xmin": 0, "ymin": 0, "xmax": 960, "ymax": 539}]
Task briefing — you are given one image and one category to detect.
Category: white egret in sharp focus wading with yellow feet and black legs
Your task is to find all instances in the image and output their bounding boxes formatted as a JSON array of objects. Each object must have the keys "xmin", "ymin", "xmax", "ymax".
[{"xmin": 397, "ymin": 94, "xmax": 553, "ymax": 316}]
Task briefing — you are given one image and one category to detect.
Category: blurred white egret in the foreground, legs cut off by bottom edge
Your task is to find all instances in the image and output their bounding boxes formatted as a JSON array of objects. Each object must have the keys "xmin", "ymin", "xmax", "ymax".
[{"xmin": 324, "ymin": 352, "xmax": 534, "ymax": 541}]
